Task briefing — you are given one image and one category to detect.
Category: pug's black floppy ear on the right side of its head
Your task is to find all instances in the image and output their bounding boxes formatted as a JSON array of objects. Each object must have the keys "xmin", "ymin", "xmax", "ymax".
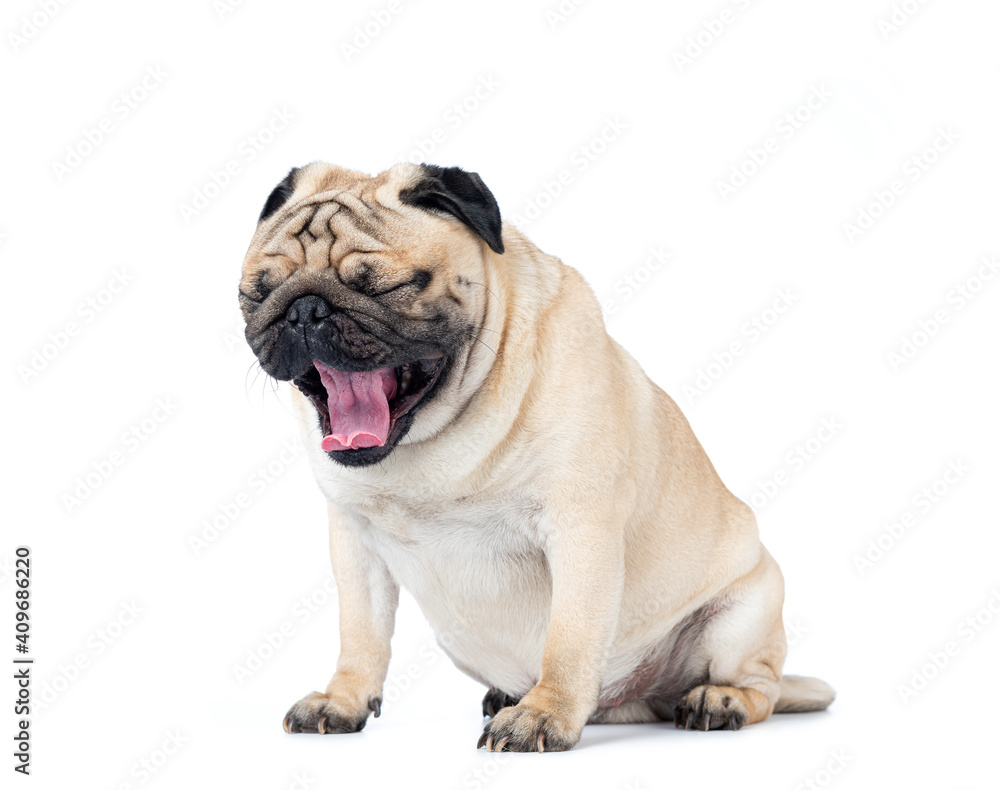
[{"xmin": 399, "ymin": 165, "xmax": 503, "ymax": 254}]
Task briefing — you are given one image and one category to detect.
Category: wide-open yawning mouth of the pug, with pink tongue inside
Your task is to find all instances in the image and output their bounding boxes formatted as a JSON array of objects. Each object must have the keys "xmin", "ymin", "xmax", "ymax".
[{"xmin": 292, "ymin": 357, "xmax": 445, "ymax": 460}]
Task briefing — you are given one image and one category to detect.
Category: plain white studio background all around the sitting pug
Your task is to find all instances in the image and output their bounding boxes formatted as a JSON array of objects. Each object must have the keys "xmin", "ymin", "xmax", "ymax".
[{"xmin": 0, "ymin": 0, "xmax": 1000, "ymax": 790}]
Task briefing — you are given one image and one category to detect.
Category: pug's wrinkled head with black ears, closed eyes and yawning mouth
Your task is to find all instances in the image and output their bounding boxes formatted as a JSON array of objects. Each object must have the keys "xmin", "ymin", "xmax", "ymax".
[{"xmin": 239, "ymin": 163, "xmax": 503, "ymax": 466}]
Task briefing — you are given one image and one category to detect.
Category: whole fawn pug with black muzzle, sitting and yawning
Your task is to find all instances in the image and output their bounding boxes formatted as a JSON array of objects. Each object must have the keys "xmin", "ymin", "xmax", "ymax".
[{"xmin": 239, "ymin": 162, "xmax": 834, "ymax": 752}]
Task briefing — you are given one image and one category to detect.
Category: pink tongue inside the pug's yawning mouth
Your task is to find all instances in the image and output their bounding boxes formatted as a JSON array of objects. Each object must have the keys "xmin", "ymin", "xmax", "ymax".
[{"xmin": 313, "ymin": 360, "xmax": 396, "ymax": 452}]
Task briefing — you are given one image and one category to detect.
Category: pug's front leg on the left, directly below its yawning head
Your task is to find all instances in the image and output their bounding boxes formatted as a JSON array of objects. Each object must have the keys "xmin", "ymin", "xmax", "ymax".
[{"xmin": 284, "ymin": 506, "xmax": 399, "ymax": 734}]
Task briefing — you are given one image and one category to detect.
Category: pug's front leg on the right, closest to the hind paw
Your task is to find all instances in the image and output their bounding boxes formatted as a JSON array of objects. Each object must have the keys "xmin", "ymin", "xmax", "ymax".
[{"xmin": 479, "ymin": 510, "xmax": 625, "ymax": 752}]
